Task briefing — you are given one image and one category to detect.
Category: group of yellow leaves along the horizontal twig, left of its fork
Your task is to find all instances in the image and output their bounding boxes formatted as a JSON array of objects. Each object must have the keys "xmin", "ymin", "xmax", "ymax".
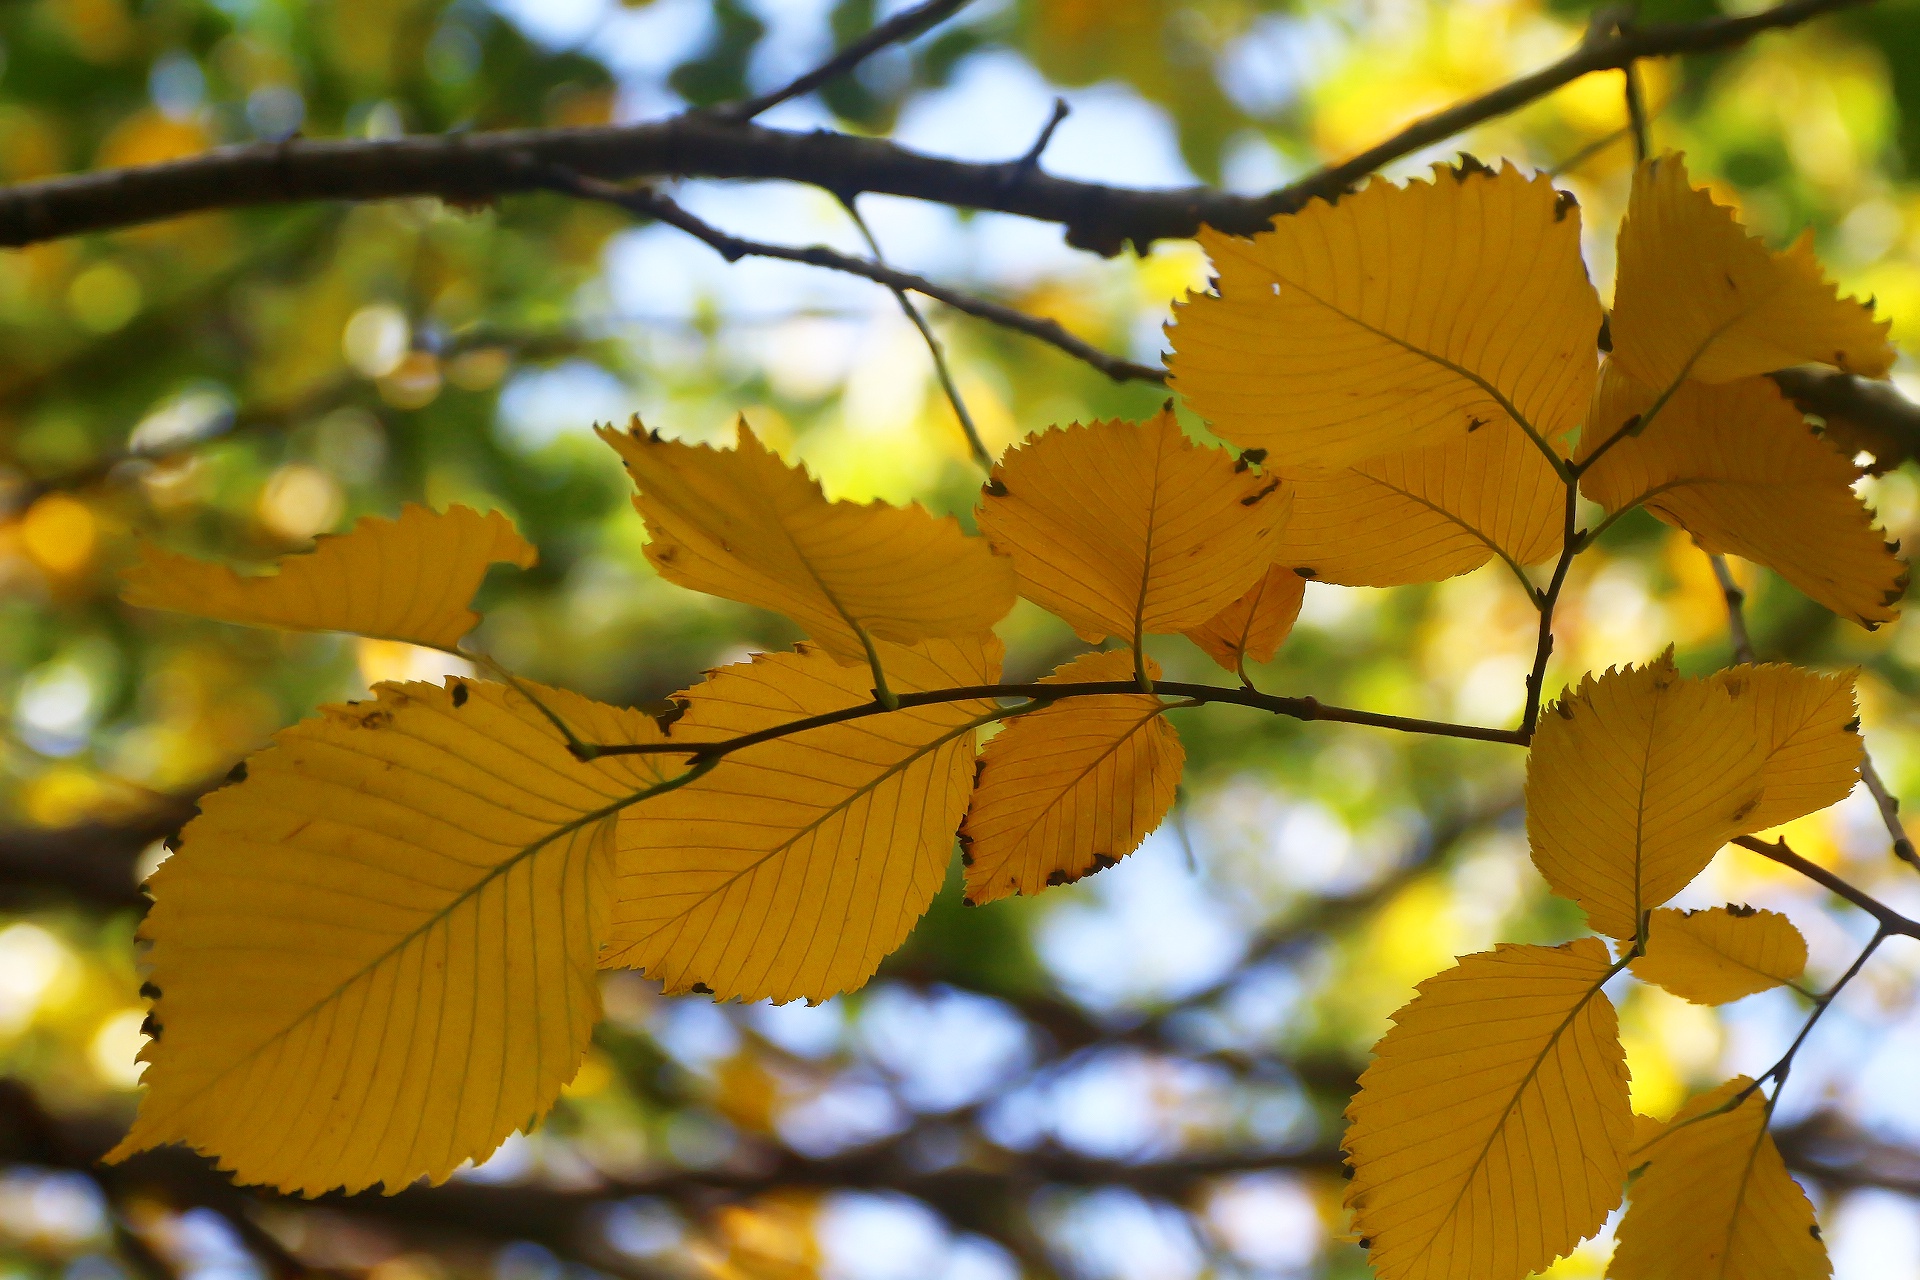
[{"xmin": 117, "ymin": 401, "xmax": 1300, "ymax": 1194}]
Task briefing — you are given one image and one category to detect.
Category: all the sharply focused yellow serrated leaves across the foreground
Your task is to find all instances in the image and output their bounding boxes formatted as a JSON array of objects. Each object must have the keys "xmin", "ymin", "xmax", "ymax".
[{"xmin": 119, "ymin": 144, "xmax": 1905, "ymax": 1280}]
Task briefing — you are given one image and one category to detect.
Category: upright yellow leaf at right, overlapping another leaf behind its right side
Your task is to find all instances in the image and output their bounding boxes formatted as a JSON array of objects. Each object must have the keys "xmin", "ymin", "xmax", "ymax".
[{"xmin": 1526, "ymin": 651, "xmax": 1764, "ymax": 938}]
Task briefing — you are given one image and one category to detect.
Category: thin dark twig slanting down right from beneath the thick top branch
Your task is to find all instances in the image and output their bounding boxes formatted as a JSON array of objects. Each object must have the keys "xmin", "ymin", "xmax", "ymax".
[{"xmin": 545, "ymin": 169, "xmax": 1165, "ymax": 382}]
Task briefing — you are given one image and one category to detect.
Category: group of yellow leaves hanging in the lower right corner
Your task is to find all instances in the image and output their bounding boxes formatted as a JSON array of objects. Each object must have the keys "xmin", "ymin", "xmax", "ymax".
[{"xmin": 1346, "ymin": 654, "xmax": 1860, "ymax": 1280}]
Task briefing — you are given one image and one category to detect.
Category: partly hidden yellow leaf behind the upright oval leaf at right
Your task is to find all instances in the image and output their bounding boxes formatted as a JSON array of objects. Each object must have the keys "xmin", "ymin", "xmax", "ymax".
[{"xmin": 1713, "ymin": 662, "xmax": 1864, "ymax": 831}]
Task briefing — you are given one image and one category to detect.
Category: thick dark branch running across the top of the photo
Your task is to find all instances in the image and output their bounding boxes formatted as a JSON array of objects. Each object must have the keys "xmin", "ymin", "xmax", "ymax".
[{"xmin": 0, "ymin": 0, "xmax": 1862, "ymax": 253}]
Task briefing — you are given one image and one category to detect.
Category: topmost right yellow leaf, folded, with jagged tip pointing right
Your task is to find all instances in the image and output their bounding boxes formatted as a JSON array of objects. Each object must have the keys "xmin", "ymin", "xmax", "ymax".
[{"xmin": 1611, "ymin": 155, "xmax": 1893, "ymax": 391}]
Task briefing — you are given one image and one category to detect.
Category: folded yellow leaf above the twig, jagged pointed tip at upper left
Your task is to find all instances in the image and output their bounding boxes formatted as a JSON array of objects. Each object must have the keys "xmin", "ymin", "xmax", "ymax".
[{"xmin": 597, "ymin": 418, "xmax": 1014, "ymax": 662}]
